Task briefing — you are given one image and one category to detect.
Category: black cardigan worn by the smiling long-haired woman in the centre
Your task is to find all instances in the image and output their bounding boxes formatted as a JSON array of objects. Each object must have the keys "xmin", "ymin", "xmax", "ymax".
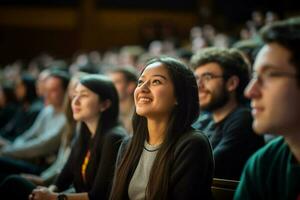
[{"xmin": 117, "ymin": 131, "xmax": 214, "ymax": 200}]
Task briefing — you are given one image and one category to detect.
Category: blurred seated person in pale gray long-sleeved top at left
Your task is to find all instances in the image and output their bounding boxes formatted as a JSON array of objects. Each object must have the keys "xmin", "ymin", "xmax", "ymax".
[{"xmin": 0, "ymin": 71, "xmax": 69, "ymax": 178}]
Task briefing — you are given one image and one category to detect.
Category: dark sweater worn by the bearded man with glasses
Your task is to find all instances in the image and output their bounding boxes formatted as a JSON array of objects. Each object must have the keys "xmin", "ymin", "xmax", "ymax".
[{"xmin": 195, "ymin": 106, "xmax": 264, "ymax": 180}]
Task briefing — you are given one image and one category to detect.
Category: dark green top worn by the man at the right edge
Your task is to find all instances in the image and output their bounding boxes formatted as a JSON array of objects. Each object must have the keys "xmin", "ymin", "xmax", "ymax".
[{"xmin": 234, "ymin": 137, "xmax": 300, "ymax": 200}]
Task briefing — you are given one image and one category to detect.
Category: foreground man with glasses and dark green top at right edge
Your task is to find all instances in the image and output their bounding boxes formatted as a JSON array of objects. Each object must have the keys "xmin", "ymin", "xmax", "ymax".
[{"xmin": 235, "ymin": 18, "xmax": 300, "ymax": 200}]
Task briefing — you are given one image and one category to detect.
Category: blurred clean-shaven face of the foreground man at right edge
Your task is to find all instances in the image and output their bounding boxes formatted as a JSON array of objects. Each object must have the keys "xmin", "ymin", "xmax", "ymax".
[{"xmin": 245, "ymin": 43, "xmax": 300, "ymax": 135}]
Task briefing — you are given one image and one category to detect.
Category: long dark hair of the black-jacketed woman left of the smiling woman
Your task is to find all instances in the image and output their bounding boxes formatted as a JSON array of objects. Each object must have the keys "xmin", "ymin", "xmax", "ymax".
[{"xmin": 76, "ymin": 74, "xmax": 119, "ymax": 185}]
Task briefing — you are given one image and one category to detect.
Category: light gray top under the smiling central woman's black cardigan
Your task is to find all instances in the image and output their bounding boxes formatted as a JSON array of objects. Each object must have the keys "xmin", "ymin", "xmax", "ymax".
[{"xmin": 128, "ymin": 141, "xmax": 160, "ymax": 200}]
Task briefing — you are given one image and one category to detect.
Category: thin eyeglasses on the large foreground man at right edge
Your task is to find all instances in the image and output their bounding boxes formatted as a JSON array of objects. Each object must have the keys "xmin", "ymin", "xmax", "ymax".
[{"xmin": 251, "ymin": 71, "xmax": 298, "ymax": 86}]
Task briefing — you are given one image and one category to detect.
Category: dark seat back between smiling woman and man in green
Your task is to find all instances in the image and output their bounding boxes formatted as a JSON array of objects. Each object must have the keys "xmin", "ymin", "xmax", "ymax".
[{"xmin": 211, "ymin": 178, "xmax": 239, "ymax": 200}]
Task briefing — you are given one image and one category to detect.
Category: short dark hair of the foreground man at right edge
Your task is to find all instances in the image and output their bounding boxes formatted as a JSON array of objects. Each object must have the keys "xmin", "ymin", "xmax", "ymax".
[{"xmin": 260, "ymin": 17, "xmax": 300, "ymax": 83}]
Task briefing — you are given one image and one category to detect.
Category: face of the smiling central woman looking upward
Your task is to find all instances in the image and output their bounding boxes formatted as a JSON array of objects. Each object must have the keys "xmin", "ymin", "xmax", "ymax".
[{"xmin": 134, "ymin": 62, "xmax": 177, "ymax": 119}]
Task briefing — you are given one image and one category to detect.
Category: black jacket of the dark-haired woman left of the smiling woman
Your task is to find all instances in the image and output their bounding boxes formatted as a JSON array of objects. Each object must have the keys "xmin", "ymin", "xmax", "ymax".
[{"xmin": 55, "ymin": 127, "xmax": 127, "ymax": 200}]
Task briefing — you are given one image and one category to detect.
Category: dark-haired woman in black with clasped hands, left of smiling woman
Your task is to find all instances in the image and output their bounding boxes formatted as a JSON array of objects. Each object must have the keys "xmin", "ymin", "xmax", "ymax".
[{"xmin": 0, "ymin": 75, "xmax": 127, "ymax": 200}]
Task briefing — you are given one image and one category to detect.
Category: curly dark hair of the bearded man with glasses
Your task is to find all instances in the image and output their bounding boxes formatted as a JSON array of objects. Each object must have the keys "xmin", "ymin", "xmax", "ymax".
[{"xmin": 190, "ymin": 47, "xmax": 250, "ymax": 103}]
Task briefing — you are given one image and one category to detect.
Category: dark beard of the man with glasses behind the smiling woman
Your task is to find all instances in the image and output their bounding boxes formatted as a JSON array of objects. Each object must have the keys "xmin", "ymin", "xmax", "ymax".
[{"xmin": 200, "ymin": 86, "xmax": 229, "ymax": 112}]
